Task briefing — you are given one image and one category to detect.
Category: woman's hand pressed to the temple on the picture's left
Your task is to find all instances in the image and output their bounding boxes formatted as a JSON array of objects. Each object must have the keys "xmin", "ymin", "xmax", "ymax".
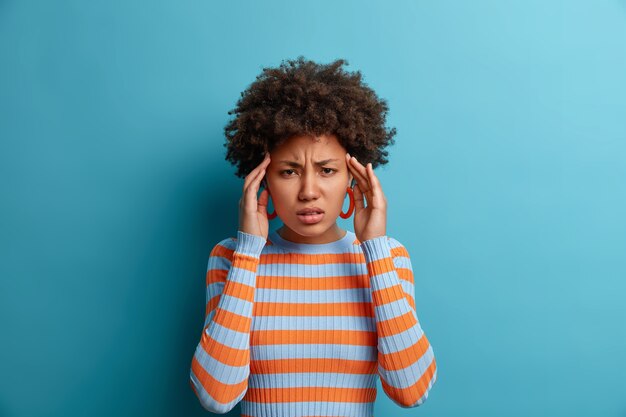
[{"xmin": 239, "ymin": 153, "xmax": 270, "ymax": 239}]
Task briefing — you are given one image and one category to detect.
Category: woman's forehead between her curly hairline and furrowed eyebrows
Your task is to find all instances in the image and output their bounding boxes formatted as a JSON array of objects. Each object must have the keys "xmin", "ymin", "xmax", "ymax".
[{"xmin": 272, "ymin": 135, "xmax": 346, "ymax": 161}]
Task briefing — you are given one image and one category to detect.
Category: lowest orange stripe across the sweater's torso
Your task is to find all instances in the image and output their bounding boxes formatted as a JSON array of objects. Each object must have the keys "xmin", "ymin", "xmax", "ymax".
[{"xmin": 246, "ymin": 387, "xmax": 376, "ymax": 403}]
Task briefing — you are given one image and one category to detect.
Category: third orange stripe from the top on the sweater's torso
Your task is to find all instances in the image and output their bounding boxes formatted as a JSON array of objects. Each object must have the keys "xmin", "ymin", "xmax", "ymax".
[{"xmin": 252, "ymin": 302, "xmax": 374, "ymax": 317}]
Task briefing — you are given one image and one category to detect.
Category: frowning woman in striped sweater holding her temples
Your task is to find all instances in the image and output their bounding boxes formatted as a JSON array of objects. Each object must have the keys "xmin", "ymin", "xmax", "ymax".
[{"xmin": 190, "ymin": 57, "xmax": 437, "ymax": 416}]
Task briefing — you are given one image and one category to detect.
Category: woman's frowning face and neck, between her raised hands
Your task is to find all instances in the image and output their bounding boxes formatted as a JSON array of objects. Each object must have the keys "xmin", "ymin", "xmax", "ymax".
[{"xmin": 265, "ymin": 135, "xmax": 352, "ymax": 243}]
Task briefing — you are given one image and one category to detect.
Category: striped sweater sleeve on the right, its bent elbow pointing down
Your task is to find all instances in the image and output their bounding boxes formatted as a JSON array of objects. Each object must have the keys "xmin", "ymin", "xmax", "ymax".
[{"xmin": 360, "ymin": 236, "xmax": 437, "ymax": 408}]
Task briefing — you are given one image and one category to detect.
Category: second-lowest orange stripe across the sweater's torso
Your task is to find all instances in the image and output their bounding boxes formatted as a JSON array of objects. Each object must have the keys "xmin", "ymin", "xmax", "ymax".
[{"xmin": 250, "ymin": 358, "xmax": 378, "ymax": 375}]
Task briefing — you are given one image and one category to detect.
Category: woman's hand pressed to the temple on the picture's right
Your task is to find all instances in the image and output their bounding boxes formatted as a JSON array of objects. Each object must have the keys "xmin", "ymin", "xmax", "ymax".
[{"xmin": 346, "ymin": 153, "xmax": 387, "ymax": 242}]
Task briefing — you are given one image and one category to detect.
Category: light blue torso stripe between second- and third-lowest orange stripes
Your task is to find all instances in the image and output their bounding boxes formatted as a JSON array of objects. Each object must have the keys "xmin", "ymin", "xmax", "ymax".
[{"xmin": 250, "ymin": 343, "xmax": 378, "ymax": 361}]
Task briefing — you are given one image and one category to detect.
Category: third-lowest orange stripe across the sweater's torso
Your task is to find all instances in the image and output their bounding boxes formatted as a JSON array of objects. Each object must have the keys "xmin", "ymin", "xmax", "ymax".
[{"xmin": 250, "ymin": 330, "xmax": 378, "ymax": 346}]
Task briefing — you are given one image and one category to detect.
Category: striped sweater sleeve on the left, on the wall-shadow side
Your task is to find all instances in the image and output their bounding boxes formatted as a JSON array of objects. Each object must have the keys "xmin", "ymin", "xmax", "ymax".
[{"xmin": 189, "ymin": 231, "xmax": 266, "ymax": 414}]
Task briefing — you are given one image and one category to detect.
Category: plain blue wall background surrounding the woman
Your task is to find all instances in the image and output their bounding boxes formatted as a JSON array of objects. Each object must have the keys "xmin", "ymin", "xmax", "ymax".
[{"xmin": 0, "ymin": 0, "xmax": 626, "ymax": 417}]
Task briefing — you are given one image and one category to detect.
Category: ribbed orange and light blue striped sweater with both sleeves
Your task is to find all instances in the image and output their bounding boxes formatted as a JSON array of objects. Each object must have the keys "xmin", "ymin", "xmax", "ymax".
[{"xmin": 189, "ymin": 231, "xmax": 437, "ymax": 417}]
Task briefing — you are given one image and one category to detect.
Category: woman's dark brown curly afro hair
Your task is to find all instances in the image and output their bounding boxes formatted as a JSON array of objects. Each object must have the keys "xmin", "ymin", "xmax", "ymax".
[{"xmin": 224, "ymin": 56, "xmax": 396, "ymax": 178}]
